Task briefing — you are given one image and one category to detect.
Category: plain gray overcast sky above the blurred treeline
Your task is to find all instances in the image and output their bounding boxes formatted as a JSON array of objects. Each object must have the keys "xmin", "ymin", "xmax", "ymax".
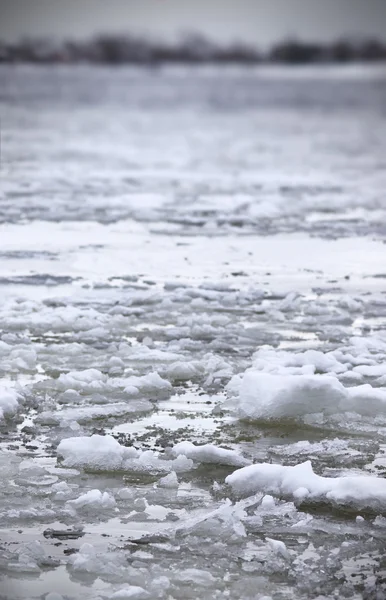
[{"xmin": 0, "ymin": 0, "xmax": 386, "ymax": 45}]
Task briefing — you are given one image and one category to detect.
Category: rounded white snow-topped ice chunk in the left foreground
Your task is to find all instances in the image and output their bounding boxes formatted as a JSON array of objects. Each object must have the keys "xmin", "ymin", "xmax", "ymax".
[{"xmin": 57, "ymin": 435, "xmax": 138, "ymax": 471}]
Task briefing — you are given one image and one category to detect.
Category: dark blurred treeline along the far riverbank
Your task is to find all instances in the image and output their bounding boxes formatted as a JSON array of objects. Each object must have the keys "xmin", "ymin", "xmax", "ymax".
[{"xmin": 0, "ymin": 35, "xmax": 386, "ymax": 65}]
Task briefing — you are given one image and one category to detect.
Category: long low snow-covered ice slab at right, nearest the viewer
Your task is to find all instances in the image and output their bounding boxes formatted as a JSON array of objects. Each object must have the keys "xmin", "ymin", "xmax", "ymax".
[{"xmin": 225, "ymin": 461, "xmax": 386, "ymax": 510}]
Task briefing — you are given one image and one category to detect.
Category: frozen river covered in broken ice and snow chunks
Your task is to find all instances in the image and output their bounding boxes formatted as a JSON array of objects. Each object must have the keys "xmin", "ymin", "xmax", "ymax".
[{"xmin": 0, "ymin": 66, "xmax": 386, "ymax": 600}]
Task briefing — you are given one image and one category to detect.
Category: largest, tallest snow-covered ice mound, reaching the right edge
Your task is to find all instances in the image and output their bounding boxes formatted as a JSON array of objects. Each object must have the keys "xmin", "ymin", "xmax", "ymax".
[{"xmin": 228, "ymin": 370, "xmax": 386, "ymax": 420}]
